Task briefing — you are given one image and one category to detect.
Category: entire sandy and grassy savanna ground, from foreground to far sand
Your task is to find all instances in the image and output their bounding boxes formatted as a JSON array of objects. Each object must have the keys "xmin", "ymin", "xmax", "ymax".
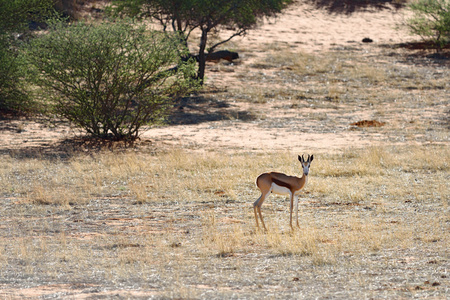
[{"xmin": 0, "ymin": 4, "xmax": 450, "ymax": 299}]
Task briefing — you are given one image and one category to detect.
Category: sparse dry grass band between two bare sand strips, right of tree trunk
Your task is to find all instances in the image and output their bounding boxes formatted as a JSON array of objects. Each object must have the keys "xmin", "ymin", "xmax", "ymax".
[{"xmin": 231, "ymin": 46, "xmax": 449, "ymax": 108}]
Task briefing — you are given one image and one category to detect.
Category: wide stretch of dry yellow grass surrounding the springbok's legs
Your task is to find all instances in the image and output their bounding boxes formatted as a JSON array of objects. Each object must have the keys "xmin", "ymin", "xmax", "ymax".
[{"xmin": 0, "ymin": 146, "xmax": 450, "ymax": 298}]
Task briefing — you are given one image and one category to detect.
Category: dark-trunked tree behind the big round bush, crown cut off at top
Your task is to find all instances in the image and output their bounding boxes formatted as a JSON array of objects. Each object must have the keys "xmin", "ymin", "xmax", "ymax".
[{"xmin": 110, "ymin": 0, "xmax": 292, "ymax": 80}]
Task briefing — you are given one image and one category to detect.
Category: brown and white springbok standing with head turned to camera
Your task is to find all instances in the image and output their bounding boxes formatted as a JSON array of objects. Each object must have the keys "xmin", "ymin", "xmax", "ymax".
[{"xmin": 253, "ymin": 154, "xmax": 314, "ymax": 231}]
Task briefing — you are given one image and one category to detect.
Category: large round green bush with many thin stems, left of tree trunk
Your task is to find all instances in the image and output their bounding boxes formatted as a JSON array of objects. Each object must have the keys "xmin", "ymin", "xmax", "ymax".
[{"xmin": 28, "ymin": 21, "xmax": 196, "ymax": 140}]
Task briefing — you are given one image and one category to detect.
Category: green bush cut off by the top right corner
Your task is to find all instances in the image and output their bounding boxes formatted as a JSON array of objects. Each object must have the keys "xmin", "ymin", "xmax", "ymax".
[{"xmin": 407, "ymin": 0, "xmax": 450, "ymax": 49}]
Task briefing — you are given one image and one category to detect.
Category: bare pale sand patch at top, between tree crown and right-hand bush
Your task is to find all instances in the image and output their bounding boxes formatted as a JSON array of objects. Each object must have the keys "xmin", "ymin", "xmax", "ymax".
[{"xmin": 232, "ymin": 3, "xmax": 411, "ymax": 53}]
